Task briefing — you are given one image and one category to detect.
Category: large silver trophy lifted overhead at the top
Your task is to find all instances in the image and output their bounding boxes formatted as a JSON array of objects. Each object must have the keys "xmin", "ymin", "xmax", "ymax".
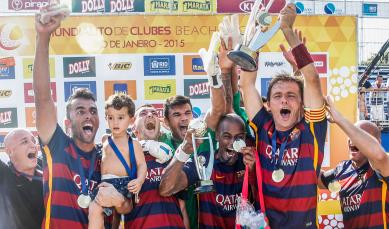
[{"xmin": 228, "ymin": 0, "xmax": 294, "ymax": 71}]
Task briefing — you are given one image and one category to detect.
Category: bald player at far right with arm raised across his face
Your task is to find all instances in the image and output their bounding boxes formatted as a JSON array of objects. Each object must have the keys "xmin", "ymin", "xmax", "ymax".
[{"xmin": 320, "ymin": 95, "xmax": 389, "ymax": 228}]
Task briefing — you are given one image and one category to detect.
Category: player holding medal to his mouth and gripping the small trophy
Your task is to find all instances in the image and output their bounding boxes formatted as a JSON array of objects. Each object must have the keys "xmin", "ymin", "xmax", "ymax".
[{"xmin": 160, "ymin": 114, "xmax": 255, "ymax": 229}]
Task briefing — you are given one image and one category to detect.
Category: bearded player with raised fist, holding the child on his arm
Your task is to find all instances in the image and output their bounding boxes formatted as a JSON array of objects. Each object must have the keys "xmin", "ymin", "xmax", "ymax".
[{"xmin": 33, "ymin": 9, "xmax": 130, "ymax": 229}]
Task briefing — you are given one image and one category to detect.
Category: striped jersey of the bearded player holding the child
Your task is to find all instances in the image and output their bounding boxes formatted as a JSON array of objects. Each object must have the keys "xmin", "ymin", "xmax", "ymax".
[{"xmin": 42, "ymin": 125, "xmax": 101, "ymax": 229}]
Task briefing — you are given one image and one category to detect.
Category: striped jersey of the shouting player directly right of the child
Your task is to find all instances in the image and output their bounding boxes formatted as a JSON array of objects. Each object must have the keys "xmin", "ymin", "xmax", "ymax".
[{"xmin": 125, "ymin": 154, "xmax": 185, "ymax": 229}]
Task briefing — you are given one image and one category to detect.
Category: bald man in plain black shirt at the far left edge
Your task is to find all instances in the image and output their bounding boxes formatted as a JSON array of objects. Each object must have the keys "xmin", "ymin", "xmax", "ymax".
[{"xmin": 0, "ymin": 129, "xmax": 44, "ymax": 229}]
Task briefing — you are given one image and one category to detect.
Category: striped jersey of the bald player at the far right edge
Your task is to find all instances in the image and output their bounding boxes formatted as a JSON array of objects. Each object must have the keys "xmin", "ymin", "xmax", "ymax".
[{"xmin": 328, "ymin": 160, "xmax": 389, "ymax": 229}]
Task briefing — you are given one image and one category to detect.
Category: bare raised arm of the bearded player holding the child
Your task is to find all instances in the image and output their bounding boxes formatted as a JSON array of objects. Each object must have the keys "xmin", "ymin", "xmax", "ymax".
[{"xmin": 33, "ymin": 15, "xmax": 61, "ymax": 144}]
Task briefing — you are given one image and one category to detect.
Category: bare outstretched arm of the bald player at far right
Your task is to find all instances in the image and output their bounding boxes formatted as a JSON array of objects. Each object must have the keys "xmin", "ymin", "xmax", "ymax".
[{"xmin": 327, "ymin": 97, "xmax": 389, "ymax": 177}]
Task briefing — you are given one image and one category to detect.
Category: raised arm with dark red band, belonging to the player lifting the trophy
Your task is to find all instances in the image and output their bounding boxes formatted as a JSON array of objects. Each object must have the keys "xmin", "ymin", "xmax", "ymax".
[{"xmin": 280, "ymin": 4, "xmax": 324, "ymax": 109}]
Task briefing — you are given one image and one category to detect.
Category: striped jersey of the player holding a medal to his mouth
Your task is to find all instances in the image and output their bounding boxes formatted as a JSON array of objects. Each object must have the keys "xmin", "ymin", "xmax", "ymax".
[{"xmin": 183, "ymin": 152, "xmax": 245, "ymax": 229}]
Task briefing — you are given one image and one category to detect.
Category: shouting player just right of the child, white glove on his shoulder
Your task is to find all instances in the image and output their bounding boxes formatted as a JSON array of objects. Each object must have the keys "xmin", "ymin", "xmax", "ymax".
[{"xmin": 121, "ymin": 105, "xmax": 189, "ymax": 229}]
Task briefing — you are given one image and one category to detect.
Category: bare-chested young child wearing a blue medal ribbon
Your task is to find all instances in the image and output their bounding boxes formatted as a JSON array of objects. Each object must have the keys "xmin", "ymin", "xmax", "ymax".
[{"xmin": 89, "ymin": 94, "xmax": 147, "ymax": 228}]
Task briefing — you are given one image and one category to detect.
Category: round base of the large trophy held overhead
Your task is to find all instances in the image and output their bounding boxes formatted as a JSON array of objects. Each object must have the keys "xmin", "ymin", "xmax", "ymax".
[{"xmin": 227, "ymin": 45, "xmax": 258, "ymax": 72}]
